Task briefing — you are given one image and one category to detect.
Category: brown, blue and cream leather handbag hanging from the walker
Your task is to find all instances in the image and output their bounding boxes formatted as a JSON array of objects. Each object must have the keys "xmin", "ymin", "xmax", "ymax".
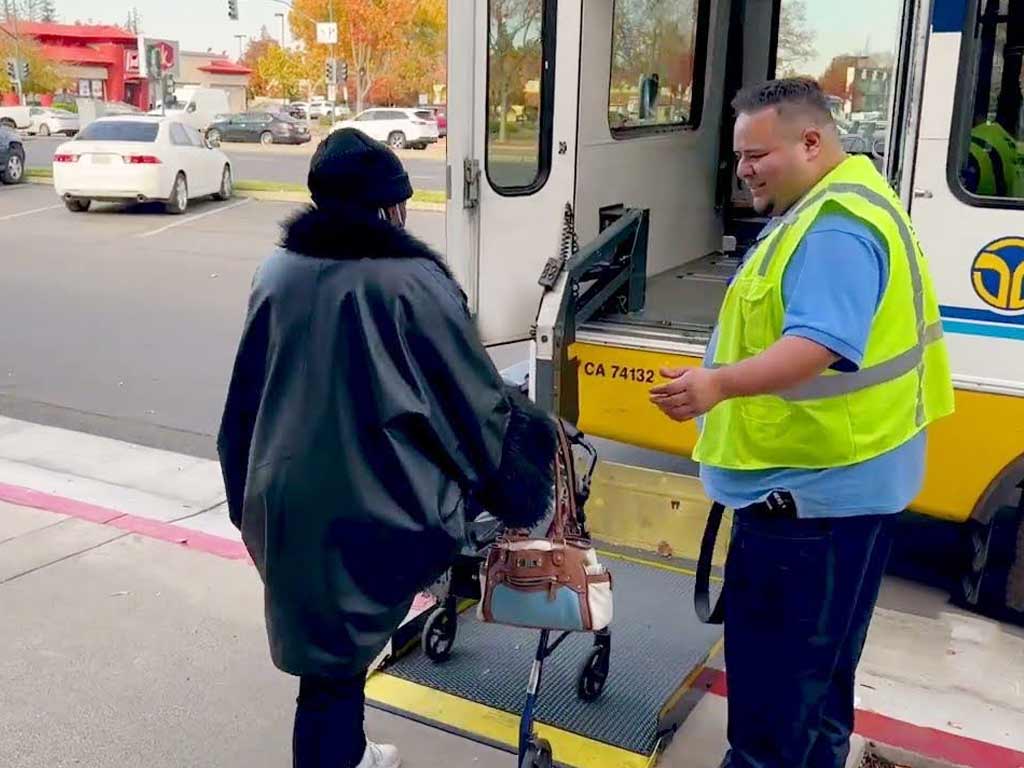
[{"xmin": 477, "ymin": 421, "xmax": 612, "ymax": 632}]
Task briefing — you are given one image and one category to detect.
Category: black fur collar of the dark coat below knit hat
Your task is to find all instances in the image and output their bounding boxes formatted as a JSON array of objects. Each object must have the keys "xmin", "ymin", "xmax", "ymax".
[{"xmin": 281, "ymin": 204, "xmax": 454, "ymax": 280}]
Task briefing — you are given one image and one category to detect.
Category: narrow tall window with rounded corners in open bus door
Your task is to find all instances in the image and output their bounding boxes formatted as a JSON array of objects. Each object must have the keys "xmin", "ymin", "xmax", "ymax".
[{"xmin": 485, "ymin": 0, "xmax": 554, "ymax": 195}]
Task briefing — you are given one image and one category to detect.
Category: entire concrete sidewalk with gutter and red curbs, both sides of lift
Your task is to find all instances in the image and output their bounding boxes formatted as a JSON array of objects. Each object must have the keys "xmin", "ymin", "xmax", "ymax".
[{"xmin": 0, "ymin": 418, "xmax": 1024, "ymax": 768}]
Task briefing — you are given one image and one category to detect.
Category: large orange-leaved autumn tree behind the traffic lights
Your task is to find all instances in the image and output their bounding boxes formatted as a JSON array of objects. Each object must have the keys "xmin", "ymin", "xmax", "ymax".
[{"xmin": 289, "ymin": 0, "xmax": 433, "ymax": 112}]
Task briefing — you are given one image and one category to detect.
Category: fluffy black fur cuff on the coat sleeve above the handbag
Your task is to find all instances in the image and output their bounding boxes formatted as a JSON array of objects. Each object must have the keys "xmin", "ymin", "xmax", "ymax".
[{"xmin": 479, "ymin": 392, "xmax": 558, "ymax": 528}]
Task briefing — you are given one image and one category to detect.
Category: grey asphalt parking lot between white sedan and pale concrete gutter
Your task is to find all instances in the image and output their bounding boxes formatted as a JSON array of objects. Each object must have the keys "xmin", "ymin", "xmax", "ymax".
[{"xmin": 0, "ymin": 184, "xmax": 444, "ymax": 458}]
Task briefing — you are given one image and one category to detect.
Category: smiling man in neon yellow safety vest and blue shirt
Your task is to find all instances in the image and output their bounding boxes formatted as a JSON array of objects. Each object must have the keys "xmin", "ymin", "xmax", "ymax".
[{"xmin": 651, "ymin": 79, "xmax": 953, "ymax": 768}]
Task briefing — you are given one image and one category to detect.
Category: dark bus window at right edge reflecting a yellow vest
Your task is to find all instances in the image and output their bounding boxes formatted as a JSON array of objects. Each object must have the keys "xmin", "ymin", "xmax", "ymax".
[{"xmin": 950, "ymin": 0, "xmax": 1024, "ymax": 207}]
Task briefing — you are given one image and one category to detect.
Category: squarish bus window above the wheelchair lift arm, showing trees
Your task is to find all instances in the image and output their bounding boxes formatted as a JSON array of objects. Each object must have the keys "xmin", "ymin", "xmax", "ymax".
[{"xmin": 608, "ymin": 0, "xmax": 707, "ymax": 138}]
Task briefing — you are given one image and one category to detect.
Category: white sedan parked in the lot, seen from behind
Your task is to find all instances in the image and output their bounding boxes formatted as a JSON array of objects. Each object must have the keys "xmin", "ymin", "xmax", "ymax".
[{"xmin": 53, "ymin": 116, "xmax": 232, "ymax": 213}]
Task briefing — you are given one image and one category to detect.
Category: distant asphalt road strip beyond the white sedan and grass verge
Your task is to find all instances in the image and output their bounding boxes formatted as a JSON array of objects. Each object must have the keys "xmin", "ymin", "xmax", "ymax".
[{"xmin": 25, "ymin": 136, "xmax": 444, "ymax": 190}]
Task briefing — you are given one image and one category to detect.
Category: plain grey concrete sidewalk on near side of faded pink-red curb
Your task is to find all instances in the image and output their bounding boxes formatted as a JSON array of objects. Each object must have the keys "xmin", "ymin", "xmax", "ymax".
[{"xmin": 0, "ymin": 504, "xmax": 513, "ymax": 768}]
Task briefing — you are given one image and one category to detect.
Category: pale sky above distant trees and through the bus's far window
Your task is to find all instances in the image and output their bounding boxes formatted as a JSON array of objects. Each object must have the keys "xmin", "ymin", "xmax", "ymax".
[{"xmin": 44, "ymin": 0, "xmax": 903, "ymax": 71}]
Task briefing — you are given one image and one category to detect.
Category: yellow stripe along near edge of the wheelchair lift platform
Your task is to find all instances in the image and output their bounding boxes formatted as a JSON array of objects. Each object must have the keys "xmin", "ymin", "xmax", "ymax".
[{"xmin": 367, "ymin": 672, "xmax": 651, "ymax": 768}]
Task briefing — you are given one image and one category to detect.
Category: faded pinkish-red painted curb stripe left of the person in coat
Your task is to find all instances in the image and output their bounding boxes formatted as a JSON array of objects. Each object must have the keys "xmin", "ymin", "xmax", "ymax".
[{"xmin": 0, "ymin": 482, "xmax": 252, "ymax": 562}]
